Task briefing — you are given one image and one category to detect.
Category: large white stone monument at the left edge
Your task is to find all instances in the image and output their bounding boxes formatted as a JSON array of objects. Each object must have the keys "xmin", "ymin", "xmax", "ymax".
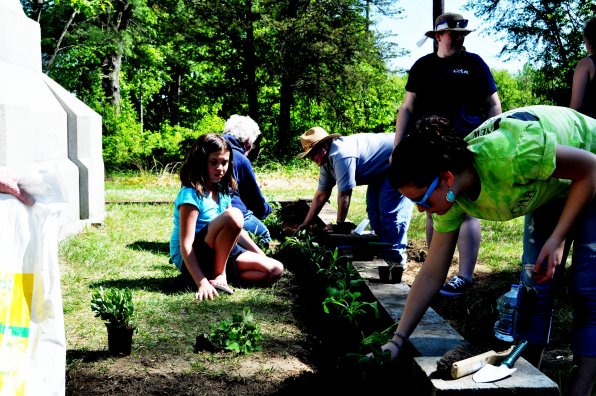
[{"xmin": 0, "ymin": 0, "xmax": 105, "ymax": 237}]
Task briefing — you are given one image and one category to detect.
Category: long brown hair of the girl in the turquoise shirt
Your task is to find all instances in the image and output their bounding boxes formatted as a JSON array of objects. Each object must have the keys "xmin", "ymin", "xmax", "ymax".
[{"xmin": 180, "ymin": 133, "xmax": 237, "ymax": 196}]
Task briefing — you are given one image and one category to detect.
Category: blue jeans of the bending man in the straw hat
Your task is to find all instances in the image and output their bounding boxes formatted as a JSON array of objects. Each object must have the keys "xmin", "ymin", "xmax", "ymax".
[{"xmin": 366, "ymin": 177, "xmax": 414, "ymax": 264}]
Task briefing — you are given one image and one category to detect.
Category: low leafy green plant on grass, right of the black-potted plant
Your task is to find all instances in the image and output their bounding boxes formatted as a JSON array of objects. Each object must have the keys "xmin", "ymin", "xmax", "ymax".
[{"xmin": 209, "ymin": 307, "xmax": 263, "ymax": 355}]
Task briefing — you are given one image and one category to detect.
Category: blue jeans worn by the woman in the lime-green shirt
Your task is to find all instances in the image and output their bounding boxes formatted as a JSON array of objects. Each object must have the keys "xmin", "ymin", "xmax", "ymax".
[{"xmin": 514, "ymin": 200, "xmax": 596, "ymax": 357}]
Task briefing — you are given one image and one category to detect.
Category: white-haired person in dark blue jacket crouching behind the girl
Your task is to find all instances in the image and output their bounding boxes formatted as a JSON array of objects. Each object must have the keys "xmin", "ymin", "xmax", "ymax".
[{"xmin": 223, "ymin": 114, "xmax": 273, "ymax": 245}]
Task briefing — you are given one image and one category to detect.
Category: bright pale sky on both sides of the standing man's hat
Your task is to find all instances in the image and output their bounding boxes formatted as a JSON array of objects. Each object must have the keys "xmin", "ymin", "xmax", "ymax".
[{"xmin": 373, "ymin": 0, "xmax": 525, "ymax": 72}]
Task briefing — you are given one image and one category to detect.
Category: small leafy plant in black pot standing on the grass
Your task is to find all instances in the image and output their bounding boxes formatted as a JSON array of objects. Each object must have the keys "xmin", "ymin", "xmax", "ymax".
[{"xmin": 91, "ymin": 286, "xmax": 135, "ymax": 356}]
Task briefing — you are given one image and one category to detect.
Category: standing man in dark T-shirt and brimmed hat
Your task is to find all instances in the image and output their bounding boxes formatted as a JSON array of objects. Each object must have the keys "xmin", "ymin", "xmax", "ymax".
[{"xmin": 395, "ymin": 12, "xmax": 501, "ymax": 297}]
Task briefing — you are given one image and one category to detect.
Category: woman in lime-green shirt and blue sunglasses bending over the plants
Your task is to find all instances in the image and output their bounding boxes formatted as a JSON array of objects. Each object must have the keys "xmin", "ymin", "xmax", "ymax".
[{"xmin": 382, "ymin": 106, "xmax": 596, "ymax": 396}]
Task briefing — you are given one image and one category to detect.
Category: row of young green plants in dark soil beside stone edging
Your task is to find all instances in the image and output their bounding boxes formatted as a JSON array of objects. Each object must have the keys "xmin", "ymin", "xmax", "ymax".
[{"xmin": 280, "ymin": 230, "xmax": 395, "ymax": 372}]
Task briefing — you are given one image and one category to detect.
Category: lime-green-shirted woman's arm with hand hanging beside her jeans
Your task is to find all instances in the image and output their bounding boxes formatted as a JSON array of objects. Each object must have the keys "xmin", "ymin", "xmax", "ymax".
[{"xmin": 534, "ymin": 146, "xmax": 596, "ymax": 282}]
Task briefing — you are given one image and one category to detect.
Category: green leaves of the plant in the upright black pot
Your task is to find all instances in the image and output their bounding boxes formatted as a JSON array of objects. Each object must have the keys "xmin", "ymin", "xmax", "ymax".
[{"xmin": 91, "ymin": 286, "xmax": 134, "ymax": 328}]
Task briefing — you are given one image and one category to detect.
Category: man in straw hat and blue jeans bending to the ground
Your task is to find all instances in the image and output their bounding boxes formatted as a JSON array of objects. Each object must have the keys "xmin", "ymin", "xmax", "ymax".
[{"xmin": 296, "ymin": 127, "xmax": 414, "ymax": 265}]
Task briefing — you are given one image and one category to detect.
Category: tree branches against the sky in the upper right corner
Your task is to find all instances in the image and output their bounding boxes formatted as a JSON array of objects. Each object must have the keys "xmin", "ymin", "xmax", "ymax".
[{"xmin": 466, "ymin": 0, "xmax": 596, "ymax": 106}]
